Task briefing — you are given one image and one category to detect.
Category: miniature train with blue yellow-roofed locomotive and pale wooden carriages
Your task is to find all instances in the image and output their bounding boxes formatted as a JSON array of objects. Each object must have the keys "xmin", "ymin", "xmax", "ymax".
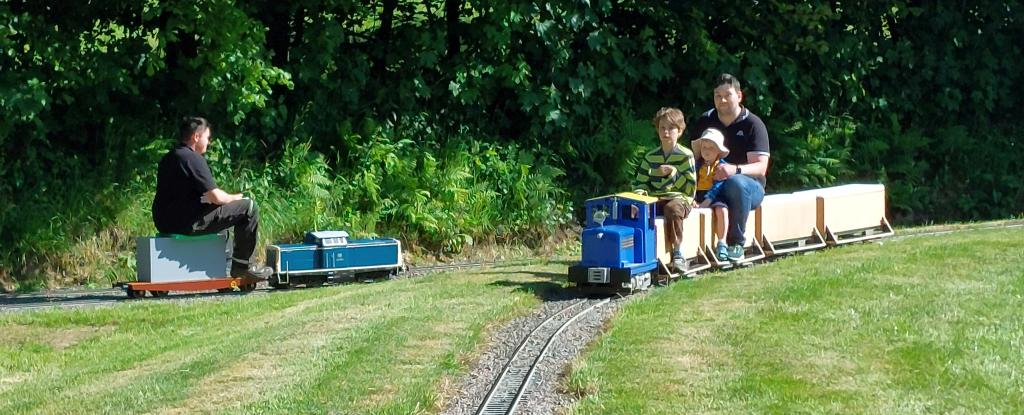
[{"xmin": 568, "ymin": 184, "xmax": 893, "ymax": 291}]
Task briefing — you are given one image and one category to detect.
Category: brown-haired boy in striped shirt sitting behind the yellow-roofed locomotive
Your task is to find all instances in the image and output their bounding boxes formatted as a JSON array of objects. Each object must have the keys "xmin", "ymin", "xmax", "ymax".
[{"xmin": 633, "ymin": 108, "xmax": 696, "ymax": 273}]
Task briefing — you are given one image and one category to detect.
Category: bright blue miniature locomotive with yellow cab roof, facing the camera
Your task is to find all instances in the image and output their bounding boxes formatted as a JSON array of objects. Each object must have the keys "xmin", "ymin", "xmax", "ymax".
[{"xmin": 569, "ymin": 193, "xmax": 658, "ymax": 290}]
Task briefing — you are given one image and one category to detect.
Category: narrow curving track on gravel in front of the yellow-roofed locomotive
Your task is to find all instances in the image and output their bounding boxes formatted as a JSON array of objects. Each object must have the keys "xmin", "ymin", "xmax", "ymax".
[{"xmin": 476, "ymin": 298, "xmax": 610, "ymax": 415}]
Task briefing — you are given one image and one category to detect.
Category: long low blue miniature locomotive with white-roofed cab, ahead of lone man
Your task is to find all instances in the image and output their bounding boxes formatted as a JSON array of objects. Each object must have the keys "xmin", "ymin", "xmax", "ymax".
[{"xmin": 266, "ymin": 231, "xmax": 402, "ymax": 288}]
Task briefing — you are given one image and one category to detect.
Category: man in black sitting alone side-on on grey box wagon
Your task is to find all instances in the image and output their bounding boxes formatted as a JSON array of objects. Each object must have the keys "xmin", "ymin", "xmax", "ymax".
[{"xmin": 153, "ymin": 117, "xmax": 271, "ymax": 279}]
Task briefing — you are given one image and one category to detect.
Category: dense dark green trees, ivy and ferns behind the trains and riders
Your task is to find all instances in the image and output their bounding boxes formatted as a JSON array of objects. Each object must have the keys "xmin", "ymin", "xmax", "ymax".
[{"xmin": 0, "ymin": 0, "xmax": 1024, "ymax": 279}]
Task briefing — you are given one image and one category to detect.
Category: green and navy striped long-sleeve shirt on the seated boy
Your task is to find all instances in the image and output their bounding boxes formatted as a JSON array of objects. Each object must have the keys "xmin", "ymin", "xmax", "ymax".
[{"xmin": 633, "ymin": 144, "xmax": 697, "ymax": 204}]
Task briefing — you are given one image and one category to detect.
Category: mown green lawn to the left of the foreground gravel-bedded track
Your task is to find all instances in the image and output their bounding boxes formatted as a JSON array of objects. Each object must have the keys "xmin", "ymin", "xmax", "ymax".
[{"xmin": 0, "ymin": 264, "xmax": 565, "ymax": 414}]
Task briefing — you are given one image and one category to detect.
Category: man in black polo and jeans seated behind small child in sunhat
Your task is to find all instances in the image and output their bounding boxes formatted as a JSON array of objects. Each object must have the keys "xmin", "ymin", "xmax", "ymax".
[{"xmin": 689, "ymin": 74, "xmax": 770, "ymax": 260}]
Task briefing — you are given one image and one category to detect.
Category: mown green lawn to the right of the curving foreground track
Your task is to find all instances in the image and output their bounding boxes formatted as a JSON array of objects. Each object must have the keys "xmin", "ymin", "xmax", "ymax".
[{"xmin": 567, "ymin": 227, "xmax": 1024, "ymax": 414}]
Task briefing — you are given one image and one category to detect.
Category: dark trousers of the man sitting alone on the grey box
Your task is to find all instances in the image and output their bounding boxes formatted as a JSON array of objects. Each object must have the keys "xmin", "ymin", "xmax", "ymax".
[{"xmin": 193, "ymin": 198, "xmax": 259, "ymax": 264}]
